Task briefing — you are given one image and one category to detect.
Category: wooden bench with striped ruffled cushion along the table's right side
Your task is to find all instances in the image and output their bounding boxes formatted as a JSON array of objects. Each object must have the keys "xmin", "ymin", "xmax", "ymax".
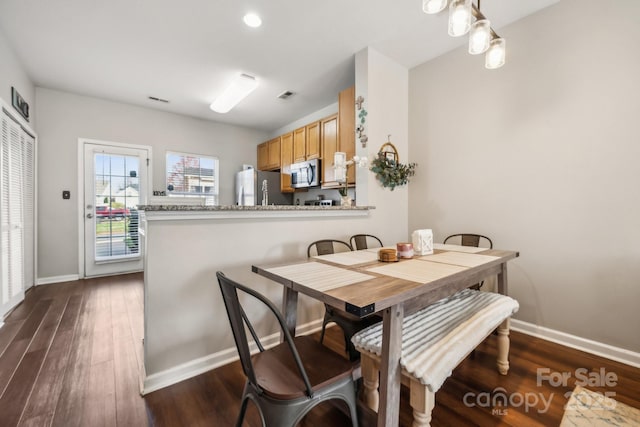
[{"xmin": 352, "ymin": 289, "xmax": 519, "ymax": 427}]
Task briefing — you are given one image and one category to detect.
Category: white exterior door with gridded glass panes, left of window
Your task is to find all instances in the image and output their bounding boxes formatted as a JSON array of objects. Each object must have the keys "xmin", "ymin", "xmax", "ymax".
[{"xmin": 83, "ymin": 141, "xmax": 149, "ymax": 277}]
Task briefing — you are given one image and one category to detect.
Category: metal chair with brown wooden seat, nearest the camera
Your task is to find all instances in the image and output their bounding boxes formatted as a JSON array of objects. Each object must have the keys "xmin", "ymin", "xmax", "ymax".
[{"xmin": 216, "ymin": 271, "xmax": 358, "ymax": 427}]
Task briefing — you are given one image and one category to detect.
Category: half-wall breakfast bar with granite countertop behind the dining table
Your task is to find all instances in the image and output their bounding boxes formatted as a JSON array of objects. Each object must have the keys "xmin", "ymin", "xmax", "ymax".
[{"xmin": 140, "ymin": 205, "xmax": 396, "ymax": 394}]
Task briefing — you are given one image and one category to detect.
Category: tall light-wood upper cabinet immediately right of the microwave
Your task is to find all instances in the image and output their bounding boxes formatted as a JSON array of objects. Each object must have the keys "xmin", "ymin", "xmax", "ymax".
[{"xmin": 320, "ymin": 86, "xmax": 356, "ymax": 188}]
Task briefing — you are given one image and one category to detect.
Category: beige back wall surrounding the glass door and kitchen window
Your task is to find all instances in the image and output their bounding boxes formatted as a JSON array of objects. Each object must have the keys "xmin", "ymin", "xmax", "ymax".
[{"xmin": 36, "ymin": 88, "xmax": 266, "ymax": 279}]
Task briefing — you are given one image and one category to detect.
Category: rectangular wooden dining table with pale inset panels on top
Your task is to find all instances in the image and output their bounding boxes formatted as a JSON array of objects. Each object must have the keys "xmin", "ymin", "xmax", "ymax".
[{"xmin": 252, "ymin": 244, "xmax": 519, "ymax": 427}]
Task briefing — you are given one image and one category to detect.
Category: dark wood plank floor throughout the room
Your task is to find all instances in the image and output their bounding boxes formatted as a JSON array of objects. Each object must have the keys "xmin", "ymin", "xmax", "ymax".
[{"xmin": 0, "ymin": 274, "xmax": 640, "ymax": 427}]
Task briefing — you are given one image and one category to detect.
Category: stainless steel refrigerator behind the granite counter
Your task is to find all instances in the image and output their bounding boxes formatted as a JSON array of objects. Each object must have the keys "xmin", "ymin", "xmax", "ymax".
[{"xmin": 236, "ymin": 169, "xmax": 293, "ymax": 206}]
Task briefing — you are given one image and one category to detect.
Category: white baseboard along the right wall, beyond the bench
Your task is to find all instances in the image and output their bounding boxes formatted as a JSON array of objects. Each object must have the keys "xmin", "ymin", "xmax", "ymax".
[{"xmin": 511, "ymin": 319, "xmax": 640, "ymax": 368}]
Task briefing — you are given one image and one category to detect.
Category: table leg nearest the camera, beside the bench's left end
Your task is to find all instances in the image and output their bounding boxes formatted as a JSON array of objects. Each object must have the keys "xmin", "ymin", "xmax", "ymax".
[{"xmin": 378, "ymin": 304, "xmax": 404, "ymax": 427}]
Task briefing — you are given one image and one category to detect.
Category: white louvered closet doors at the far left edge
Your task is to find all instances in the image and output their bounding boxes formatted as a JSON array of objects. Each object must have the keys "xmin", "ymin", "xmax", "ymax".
[{"xmin": 0, "ymin": 109, "xmax": 35, "ymax": 316}]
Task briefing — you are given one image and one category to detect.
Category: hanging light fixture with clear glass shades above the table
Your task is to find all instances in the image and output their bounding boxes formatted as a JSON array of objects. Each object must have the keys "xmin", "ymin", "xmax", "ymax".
[{"xmin": 422, "ymin": 0, "xmax": 506, "ymax": 70}]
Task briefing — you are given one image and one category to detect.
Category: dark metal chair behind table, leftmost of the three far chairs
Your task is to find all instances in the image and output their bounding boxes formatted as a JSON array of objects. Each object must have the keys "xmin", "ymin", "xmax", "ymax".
[{"xmin": 307, "ymin": 239, "xmax": 380, "ymax": 361}]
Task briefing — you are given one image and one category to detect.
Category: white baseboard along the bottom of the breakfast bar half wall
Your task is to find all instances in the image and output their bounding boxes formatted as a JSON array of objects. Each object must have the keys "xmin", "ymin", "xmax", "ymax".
[{"xmin": 140, "ymin": 319, "xmax": 322, "ymax": 396}]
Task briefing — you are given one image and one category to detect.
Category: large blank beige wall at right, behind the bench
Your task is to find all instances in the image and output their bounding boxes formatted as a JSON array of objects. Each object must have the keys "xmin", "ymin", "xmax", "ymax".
[{"xmin": 409, "ymin": 0, "xmax": 640, "ymax": 352}]
